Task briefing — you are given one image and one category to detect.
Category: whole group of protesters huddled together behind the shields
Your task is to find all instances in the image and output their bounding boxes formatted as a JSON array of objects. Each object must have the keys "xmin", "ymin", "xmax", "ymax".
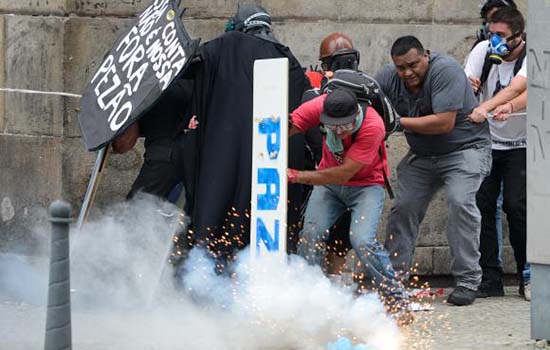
[{"xmin": 113, "ymin": 0, "xmax": 530, "ymax": 324}]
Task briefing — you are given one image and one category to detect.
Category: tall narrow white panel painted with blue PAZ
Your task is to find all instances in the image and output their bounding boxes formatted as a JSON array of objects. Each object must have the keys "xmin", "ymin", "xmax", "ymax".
[{"xmin": 250, "ymin": 58, "xmax": 288, "ymax": 257}]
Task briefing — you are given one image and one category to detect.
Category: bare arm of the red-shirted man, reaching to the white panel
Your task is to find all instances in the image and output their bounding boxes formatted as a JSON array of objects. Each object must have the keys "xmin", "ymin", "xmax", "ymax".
[{"xmin": 295, "ymin": 158, "xmax": 363, "ymax": 185}]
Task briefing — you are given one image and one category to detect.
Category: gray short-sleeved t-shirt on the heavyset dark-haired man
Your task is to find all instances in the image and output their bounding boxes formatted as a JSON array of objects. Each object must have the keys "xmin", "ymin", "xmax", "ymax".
[{"xmin": 376, "ymin": 53, "xmax": 491, "ymax": 155}]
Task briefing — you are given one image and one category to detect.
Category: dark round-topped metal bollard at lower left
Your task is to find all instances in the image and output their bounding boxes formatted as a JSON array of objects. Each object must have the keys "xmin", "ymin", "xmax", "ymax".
[{"xmin": 44, "ymin": 201, "xmax": 72, "ymax": 350}]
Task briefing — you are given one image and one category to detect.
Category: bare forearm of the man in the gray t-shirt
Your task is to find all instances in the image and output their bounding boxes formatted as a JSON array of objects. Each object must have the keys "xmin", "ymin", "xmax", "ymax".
[{"xmin": 400, "ymin": 111, "xmax": 456, "ymax": 135}]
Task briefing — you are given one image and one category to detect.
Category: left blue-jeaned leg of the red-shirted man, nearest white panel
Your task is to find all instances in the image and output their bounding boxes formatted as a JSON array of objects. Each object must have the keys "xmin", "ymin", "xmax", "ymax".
[{"xmin": 298, "ymin": 186, "xmax": 346, "ymax": 266}]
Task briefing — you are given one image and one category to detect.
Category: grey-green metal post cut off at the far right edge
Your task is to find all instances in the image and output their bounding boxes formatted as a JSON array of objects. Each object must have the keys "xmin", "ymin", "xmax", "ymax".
[{"xmin": 527, "ymin": 0, "xmax": 550, "ymax": 339}]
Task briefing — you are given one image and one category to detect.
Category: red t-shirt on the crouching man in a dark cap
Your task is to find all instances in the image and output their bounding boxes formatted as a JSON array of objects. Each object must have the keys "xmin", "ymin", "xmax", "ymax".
[{"xmin": 291, "ymin": 95, "xmax": 389, "ymax": 186}]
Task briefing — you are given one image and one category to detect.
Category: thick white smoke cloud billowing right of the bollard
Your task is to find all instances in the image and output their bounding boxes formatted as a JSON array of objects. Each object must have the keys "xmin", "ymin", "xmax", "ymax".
[{"xmin": 0, "ymin": 197, "xmax": 401, "ymax": 350}]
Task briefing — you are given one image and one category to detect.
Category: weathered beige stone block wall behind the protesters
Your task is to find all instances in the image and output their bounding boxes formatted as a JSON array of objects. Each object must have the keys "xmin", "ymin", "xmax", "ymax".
[{"xmin": 0, "ymin": 0, "xmax": 527, "ymax": 274}]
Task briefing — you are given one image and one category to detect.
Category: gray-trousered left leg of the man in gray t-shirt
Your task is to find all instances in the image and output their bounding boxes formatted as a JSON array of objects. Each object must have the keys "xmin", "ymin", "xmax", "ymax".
[{"xmin": 385, "ymin": 152, "xmax": 441, "ymax": 276}]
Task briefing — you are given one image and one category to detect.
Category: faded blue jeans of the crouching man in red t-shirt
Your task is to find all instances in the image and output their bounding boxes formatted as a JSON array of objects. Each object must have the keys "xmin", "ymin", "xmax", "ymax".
[{"xmin": 298, "ymin": 185, "xmax": 405, "ymax": 299}]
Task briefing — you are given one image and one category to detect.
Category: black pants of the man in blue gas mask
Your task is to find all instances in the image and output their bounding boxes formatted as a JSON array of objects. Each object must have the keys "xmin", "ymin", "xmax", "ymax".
[{"xmin": 476, "ymin": 148, "xmax": 527, "ymax": 281}]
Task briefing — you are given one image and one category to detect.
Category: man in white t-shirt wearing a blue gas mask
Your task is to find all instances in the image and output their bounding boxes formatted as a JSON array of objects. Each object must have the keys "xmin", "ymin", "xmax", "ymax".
[{"xmin": 465, "ymin": 7, "xmax": 529, "ymax": 297}]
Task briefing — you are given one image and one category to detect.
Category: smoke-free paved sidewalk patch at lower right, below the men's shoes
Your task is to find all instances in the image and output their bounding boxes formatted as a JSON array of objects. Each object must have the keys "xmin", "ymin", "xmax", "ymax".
[{"xmin": 403, "ymin": 287, "xmax": 540, "ymax": 350}]
